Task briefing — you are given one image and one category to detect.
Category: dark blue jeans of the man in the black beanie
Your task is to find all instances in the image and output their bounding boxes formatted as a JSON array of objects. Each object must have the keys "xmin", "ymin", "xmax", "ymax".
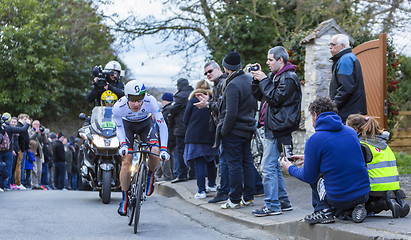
[{"xmin": 222, "ymin": 134, "xmax": 255, "ymax": 203}]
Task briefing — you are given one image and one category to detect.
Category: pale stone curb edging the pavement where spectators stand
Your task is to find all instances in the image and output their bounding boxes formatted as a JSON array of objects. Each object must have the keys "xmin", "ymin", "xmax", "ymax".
[{"xmin": 156, "ymin": 182, "xmax": 411, "ymax": 240}]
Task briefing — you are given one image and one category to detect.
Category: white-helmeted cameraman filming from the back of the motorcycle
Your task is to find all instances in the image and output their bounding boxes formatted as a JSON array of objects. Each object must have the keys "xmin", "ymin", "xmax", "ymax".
[{"xmin": 86, "ymin": 61, "xmax": 124, "ymax": 107}]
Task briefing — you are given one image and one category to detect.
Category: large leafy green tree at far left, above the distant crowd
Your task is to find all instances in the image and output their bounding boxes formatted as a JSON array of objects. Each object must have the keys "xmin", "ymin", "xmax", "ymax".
[{"xmin": 0, "ymin": 0, "xmax": 118, "ymax": 123}]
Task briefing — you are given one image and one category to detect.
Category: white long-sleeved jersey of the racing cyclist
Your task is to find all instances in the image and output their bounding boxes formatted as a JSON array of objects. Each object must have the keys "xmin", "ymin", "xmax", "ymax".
[{"xmin": 113, "ymin": 94, "xmax": 168, "ymax": 150}]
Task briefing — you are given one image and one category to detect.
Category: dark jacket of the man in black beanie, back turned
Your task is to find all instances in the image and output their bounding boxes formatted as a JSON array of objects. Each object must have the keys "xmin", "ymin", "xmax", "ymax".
[{"xmin": 216, "ymin": 70, "xmax": 257, "ymax": 140}]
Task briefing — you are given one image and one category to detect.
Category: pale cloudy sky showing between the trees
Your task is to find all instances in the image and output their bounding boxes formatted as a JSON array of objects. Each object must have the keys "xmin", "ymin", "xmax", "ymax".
[{"xmin": 99, "ymin": 0, "xmax": 411, "ymax": 88}]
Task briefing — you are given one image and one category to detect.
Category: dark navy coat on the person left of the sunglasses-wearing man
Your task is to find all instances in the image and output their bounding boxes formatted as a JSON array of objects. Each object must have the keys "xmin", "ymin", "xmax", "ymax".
[{"xmin": 184, "ymin": 89, "xmax": 214, "ymax": 145}]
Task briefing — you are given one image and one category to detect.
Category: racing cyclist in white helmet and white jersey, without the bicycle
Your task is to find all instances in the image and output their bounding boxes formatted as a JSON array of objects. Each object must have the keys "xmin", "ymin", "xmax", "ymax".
[{"xmin": 113, "ymin": 80, "xmax": 170, "ymax": 216}]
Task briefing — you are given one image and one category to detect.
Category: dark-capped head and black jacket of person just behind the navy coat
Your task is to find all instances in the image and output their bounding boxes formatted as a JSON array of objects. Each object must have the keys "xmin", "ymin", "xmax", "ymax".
[{"xmin": 170, "ymin": 79, "xmax": 194, "ymax": 137}]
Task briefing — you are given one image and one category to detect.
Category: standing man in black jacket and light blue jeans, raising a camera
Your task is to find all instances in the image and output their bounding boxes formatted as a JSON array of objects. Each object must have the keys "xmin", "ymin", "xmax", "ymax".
[{"xmin": 251, "ymin": 46, "xmax": 302, "ymax": 217}]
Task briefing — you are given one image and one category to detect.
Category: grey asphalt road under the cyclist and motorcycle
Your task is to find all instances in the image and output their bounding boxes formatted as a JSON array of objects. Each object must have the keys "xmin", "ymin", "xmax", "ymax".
[{"xmin": 0, "ymin": 190, "xmax": 277, "ymax": 240}]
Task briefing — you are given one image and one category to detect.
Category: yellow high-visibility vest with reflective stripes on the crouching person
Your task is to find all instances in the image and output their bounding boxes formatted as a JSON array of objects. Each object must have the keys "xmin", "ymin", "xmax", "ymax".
[{"xmin": 361, "ymin": 142, "xmax": 400, "ymax": 192}]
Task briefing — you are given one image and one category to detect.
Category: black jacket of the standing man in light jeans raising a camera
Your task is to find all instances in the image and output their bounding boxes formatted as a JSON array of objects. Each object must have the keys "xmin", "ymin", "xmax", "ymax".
[{"xmin": 252, "ymin": 63, "xmax": 302, "ymax": 139}]
